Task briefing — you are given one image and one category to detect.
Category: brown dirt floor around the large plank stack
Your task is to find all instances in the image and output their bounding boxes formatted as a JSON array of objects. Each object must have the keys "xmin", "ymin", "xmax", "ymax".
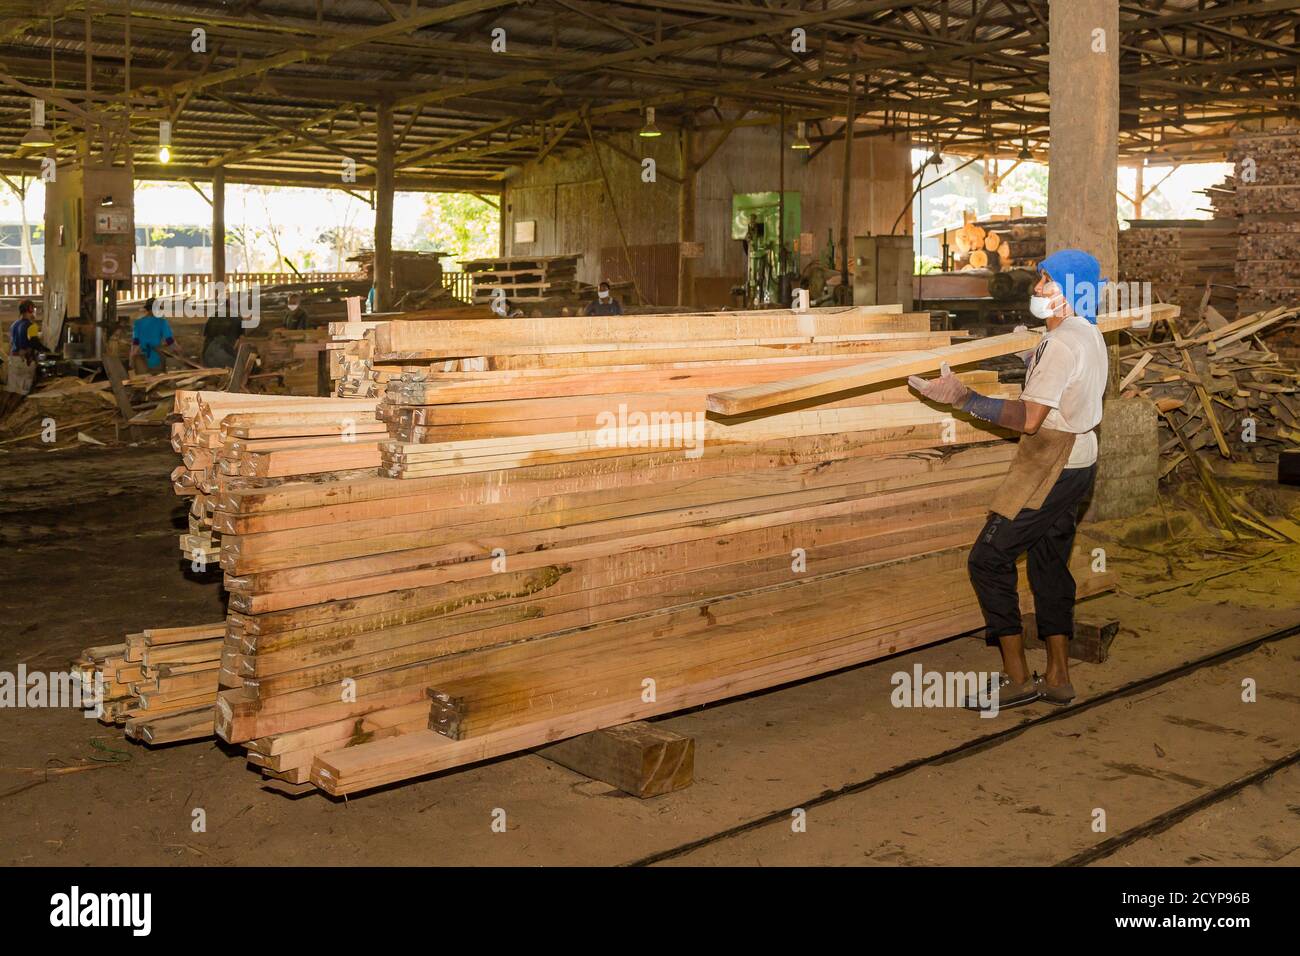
[{"xmin": 0, "ymin": 445, "xmax": 1300, "ymax": 866}]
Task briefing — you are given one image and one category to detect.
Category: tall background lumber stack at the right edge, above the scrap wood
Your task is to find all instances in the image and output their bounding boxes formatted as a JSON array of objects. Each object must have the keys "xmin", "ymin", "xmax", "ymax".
[{"xmin": 1231, "ymin": 126, "xmax": 1300, "ymax": 311}]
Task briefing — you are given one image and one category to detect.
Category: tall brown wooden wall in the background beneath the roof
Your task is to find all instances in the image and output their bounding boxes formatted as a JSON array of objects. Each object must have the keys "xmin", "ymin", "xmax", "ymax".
[{"xmin": 503, "ymin": 119, "xmax": 911, "ymax": 306}]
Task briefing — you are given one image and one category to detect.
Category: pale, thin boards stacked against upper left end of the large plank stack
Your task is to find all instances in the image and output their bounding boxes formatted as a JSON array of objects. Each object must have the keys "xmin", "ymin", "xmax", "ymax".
[{"xmin": 172, "ymin": 392, "xmax": 385, "ymax": 568}]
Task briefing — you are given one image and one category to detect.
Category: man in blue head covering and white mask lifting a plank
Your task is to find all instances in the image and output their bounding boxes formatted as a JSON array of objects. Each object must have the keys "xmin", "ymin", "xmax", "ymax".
[{"xmin": 907, "ymin": 248, "xmax": 1108, "ymax": 710}]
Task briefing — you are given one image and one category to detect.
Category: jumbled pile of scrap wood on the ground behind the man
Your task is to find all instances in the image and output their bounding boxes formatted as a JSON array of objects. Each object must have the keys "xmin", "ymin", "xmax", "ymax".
[{"xmin": 1121, "ymin": 306, "xmax": 1300, "ymax": 540}]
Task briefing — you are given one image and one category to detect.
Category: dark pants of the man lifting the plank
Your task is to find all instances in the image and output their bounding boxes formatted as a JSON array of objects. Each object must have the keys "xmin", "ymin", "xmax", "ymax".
[{"xmin": 966, "ymin": 464, "xmax": 1097, "ymax": 639}]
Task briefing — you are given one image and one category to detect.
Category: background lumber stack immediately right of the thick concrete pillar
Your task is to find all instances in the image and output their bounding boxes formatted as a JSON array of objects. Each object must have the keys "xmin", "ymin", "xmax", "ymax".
[{"xmin": 1119, "ymin": 219, "xmax": 1238, "ymax": 319}]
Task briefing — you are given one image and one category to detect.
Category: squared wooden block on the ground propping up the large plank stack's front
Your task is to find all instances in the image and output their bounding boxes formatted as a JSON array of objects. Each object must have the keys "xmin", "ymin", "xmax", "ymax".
[{"xmin": 537, "ymin": 721, "xmax": 696, "ymax": 799}]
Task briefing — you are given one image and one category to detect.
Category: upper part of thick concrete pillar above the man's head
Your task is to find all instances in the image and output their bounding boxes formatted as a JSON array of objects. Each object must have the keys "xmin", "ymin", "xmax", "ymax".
[{"xmin": 1047, "ymin": 0, "xmax": 1119, "ymax": 278}]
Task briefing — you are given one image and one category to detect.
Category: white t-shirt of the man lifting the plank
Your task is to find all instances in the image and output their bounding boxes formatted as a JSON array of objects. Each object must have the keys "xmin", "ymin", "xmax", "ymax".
[{"xmin": 1021, "ymin": 315, "xmax": 1109, "ymax": 468}]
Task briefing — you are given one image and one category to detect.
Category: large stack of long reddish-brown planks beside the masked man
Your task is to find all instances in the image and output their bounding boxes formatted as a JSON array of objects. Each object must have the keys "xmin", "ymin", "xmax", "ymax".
[{"xmin": 195, "ymin": 308, "xmax": 1138, "ymax": 793}]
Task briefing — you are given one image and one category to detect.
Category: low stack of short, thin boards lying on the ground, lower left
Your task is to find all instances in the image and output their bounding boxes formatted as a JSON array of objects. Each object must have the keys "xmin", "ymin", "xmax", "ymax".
[{"xmin": 73, "ymin": 622, "xmax": 226, "ymax": 744}]
